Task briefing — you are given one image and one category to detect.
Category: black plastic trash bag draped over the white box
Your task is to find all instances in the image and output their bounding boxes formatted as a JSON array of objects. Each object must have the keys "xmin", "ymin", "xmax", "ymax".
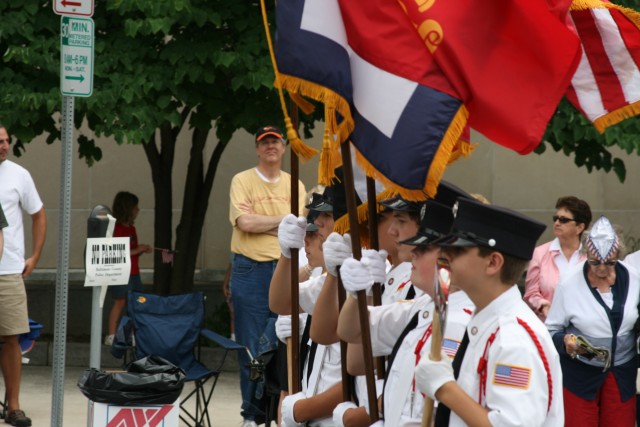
[{"xmin": 78, "ymin": 356, "xmax": 186, "ymax": 406}]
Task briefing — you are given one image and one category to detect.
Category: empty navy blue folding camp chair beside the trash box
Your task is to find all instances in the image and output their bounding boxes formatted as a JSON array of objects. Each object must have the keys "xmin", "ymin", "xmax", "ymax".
[{"xmin": 128, "ymin": 292, "xmax": 245, "ymax": 427}]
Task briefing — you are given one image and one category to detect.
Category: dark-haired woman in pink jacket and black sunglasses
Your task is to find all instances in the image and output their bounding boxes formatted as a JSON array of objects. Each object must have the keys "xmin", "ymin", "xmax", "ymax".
[{"xmin": 524, "ymin": 196, "xmax": 591, "ymax": 322}]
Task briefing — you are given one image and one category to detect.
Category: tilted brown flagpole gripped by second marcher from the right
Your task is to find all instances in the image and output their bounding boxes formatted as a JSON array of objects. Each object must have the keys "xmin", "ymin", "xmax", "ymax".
[{"xmin": 340, "ymin": 143, "xmax": 378, "ymax": 423}]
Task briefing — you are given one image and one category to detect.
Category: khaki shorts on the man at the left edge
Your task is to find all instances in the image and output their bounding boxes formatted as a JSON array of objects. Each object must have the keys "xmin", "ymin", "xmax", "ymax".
[{"xmin": 0, "ymin": 274, "xmax": 29, "ymax": 336}]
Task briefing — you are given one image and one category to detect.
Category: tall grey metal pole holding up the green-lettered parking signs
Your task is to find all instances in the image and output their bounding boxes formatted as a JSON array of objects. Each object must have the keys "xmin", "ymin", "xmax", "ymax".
[{"xmin": 51, "ymin": 96, "xmax": 74, "ymax": 427}]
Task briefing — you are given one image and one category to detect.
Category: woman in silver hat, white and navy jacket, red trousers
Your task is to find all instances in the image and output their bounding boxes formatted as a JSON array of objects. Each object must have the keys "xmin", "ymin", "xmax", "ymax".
[{"xmin": 546, "ymin": 216, "xmax": 640, "ymax": 427}]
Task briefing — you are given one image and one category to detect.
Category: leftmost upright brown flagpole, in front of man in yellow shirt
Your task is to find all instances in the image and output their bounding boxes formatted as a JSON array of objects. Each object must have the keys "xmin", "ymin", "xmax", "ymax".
[{"xmin": 287, "ymin": 101, "xmax": 300, "ymax": 394}]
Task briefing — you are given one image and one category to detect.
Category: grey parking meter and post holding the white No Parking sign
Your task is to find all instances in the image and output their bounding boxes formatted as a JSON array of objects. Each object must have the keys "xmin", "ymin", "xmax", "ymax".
[{"xmin": 85, "ymin": 205, "xmax": 113, "ymax": 369}]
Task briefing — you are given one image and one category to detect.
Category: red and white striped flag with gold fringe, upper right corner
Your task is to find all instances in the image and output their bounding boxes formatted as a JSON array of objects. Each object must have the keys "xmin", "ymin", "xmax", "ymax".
[{"xmin": 567, "ymin": 0, "xmax": 640, "ymax": 132}]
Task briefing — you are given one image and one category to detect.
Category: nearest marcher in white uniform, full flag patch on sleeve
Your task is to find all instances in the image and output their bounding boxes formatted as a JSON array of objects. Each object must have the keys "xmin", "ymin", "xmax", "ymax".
[{"xmin": 416, "ymin": 199, "xmax": 564, "ymax": 427}]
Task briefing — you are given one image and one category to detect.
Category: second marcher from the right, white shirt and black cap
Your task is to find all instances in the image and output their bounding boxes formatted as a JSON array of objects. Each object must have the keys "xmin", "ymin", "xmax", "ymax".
[{"xmin": 334, "ymin": 200, "xmax": 473, "ymax": 427}]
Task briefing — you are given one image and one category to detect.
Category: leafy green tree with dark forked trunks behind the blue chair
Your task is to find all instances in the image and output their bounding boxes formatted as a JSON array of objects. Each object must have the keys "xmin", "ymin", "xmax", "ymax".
[{"xmin": 0, "ymin": 0, "xmax": 321, "ymax": 293}]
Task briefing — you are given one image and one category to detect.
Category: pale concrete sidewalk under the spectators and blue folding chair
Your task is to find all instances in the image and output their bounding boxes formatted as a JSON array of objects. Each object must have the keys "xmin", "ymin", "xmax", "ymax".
[{"xmin": 0, "ymin": 365, "xmax": 242, "ymax": 427}]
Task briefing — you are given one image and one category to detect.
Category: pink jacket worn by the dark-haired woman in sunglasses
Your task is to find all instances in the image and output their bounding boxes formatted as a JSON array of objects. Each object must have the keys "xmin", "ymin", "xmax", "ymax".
[{"xmin": 524, "ymin": 240, "xmax": 586, "ymax": 322}]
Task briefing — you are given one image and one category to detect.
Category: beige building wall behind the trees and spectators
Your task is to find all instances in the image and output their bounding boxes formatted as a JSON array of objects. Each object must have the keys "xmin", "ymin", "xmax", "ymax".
[{"xmin": 12, "ymin": 126, "xmax": 640, "ymax": 279}]
